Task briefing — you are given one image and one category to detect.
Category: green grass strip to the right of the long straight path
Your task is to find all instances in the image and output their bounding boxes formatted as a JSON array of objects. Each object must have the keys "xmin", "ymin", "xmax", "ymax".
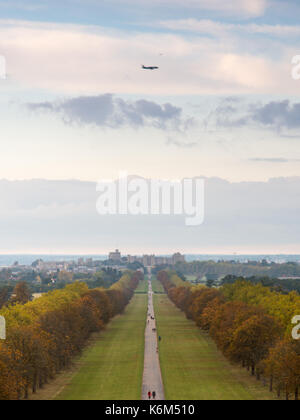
[{"xmin": 154, "ymin": 295, "xmax": 276, "ymax": 400}]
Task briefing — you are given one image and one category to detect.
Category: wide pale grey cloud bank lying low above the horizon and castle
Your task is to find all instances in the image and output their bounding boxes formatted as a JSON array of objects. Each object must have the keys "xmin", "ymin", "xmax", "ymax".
[{"xmin": 0, "ymin": 177, "xmax": 300, "ymax": 253}]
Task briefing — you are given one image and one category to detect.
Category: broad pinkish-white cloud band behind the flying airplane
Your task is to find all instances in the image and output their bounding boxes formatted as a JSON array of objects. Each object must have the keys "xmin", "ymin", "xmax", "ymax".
[{"xmin": 0, "ymin": 21, "xmax": 295, "ymax": 95}]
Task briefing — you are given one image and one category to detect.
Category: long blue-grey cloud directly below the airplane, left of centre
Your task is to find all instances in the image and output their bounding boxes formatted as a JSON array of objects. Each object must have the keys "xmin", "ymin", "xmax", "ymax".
[{"xmin": 27, "ymin": 94, "xmax": 193, "ymax": 130}]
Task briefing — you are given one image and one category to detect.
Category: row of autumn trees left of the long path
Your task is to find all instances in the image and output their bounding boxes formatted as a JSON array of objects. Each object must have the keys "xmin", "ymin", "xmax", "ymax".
[{"xmin": 0, "ymin": 271, "xmax": 143, "ymax": 400}]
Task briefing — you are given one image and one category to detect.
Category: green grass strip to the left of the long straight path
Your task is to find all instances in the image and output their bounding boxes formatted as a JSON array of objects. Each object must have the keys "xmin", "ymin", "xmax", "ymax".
[{"xmin": 56, "ymin": 294, "xmax": 147, "ymax": 400}]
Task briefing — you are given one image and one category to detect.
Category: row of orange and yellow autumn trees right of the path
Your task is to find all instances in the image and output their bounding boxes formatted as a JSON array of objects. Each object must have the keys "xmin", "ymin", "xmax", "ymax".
[{"xmin": 158, "ymin": 271, "xmax": 300, "ymax": 400}]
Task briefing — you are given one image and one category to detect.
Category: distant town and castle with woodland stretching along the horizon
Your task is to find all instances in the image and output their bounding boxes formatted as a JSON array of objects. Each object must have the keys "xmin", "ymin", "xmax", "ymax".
[{"xmin": 0, "ymin": 249, "xmax": 300, "ymax": 298}]
